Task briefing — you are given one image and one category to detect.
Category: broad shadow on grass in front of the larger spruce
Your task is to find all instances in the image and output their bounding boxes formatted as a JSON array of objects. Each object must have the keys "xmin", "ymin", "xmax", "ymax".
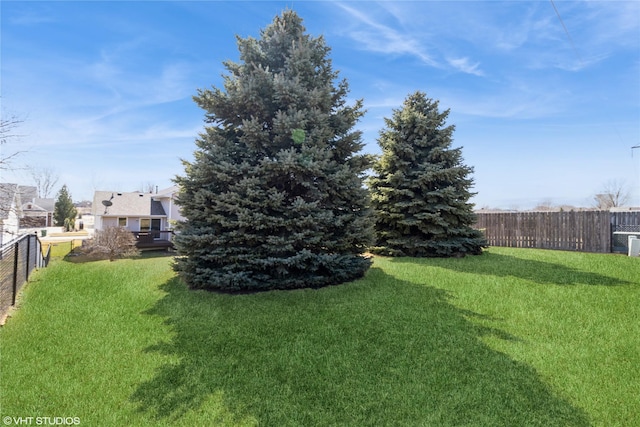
[{"xmin": 131, "ymin": 268, "xmax": 589, "ymax": 427}]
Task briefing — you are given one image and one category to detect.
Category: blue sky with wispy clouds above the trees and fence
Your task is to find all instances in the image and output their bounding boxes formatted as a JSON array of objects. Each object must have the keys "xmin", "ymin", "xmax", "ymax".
[{"xmin": 0, "ymin": 0, "xmax": 640, "ymax": 209}]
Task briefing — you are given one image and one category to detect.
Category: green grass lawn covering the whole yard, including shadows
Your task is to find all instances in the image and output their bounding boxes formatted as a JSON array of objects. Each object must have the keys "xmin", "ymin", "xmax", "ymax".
[{"xmin": 0, "ymin": 248, "xmax": 640, "ymax": 427}]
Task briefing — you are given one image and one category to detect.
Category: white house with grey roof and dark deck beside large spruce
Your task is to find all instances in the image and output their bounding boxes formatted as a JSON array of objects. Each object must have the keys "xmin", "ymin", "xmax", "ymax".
[{"xmin": 93, "ymin": 187, "xmax": 182, "ymax": 247}]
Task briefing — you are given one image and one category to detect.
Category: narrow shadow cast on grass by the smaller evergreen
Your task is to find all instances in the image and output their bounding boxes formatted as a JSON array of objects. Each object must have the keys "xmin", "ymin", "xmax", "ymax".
[{"xmin": 391, "ymin": 252, "xmax": 632, "ymax": 286}]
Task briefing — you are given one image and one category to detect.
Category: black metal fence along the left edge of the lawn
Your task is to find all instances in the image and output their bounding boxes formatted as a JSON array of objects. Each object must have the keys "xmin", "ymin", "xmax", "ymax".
[{"xmin": 0, "ymin": 234, "xmax": 49, "ymax": 321}]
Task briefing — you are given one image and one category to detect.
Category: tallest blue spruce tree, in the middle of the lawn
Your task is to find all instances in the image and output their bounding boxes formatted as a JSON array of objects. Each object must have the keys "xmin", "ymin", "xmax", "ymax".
[{"xmin": 175, "ymin": 10, "xmax": 373, "ymax": 291}]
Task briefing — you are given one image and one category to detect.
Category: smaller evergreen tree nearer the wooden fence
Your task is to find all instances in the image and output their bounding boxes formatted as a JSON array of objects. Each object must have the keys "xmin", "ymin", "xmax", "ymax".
[{"xmin": 369, "ymin": 92, "xmax": 487, "ymax": 257}]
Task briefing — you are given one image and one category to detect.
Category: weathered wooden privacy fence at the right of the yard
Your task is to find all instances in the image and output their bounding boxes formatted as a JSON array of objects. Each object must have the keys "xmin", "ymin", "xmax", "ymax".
[{"xmin": 476, "ymin": 211, "xmax": 640, "ymax": 253}]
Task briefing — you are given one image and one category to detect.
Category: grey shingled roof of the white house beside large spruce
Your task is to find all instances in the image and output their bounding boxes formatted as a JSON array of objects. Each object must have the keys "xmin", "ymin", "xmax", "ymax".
[{"xmin": 93, "ymin": 191, "xmax": 167, "ymax": 217}]
